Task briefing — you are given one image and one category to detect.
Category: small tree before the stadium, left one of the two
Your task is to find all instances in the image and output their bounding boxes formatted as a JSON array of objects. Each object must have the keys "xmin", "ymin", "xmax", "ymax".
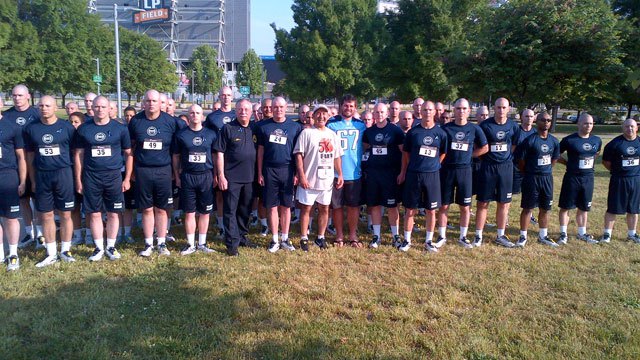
[{"xmin": 189, "ymin": 45, "xmax": 224, "ymax": 95}]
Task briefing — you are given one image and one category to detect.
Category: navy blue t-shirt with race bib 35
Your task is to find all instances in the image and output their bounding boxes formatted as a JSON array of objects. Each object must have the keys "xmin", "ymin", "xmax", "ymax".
[{"xmin": 74, "ymin": 120, "xmax": 131, "ymax": 171}]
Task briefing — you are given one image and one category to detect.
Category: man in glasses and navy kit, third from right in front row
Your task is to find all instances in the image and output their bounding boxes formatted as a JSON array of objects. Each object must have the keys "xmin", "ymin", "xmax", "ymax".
[{"xmin": 515, "ymin": 111, "xmax": 560, "ymax": 248}]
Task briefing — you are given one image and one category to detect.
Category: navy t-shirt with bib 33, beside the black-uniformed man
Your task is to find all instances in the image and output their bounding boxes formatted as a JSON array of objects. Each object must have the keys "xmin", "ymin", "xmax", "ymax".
[{"xmin": 173, "ymin": 127, "xmax": 218, "ymax": 174}]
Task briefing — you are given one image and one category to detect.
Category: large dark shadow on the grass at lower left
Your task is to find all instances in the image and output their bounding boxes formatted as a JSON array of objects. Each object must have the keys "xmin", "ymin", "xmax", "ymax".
[{"xmin": 0, "ymin": 262, "xmax": 335, "ymax": 359}]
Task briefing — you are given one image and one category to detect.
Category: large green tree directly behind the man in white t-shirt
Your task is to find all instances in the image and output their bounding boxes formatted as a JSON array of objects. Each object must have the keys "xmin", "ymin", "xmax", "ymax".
[{"xmin": 271, "ymin": 0, "xmax": 384, "ymax": 101}]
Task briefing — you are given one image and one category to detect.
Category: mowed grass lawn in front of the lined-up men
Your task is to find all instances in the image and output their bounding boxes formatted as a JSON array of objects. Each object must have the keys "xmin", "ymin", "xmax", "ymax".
[{"xmin": 0, "ymin": 131, "xmax": 640, "ymax": 359}]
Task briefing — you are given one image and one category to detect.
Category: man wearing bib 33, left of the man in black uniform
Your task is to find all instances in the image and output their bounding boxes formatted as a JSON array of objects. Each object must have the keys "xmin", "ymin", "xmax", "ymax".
[{"xmin": 172, "ymin": 105, "xmax": 218, "ymax": 255}]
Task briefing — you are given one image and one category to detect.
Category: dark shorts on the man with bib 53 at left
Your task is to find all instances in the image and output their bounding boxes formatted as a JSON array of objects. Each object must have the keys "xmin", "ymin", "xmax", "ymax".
[{"xmin": 35, "ymin": 167, "xmax": 75, "ymax": 212}]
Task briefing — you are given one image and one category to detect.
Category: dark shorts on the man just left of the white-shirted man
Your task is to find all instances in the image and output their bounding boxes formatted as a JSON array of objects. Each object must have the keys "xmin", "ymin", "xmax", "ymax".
[{"xmin": 262, "ymin": 166, "xmax": 295, "ymax": 209}]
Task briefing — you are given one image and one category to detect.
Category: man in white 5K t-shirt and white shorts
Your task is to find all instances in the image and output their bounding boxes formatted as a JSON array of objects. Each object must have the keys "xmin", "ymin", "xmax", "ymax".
[{"xmin": 293, "ymin": 105, "xmax": 344, "ymax": 251}]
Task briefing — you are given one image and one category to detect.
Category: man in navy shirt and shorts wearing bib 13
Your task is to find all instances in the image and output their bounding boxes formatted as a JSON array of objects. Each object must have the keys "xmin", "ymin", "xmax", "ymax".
[{"xmin": 398, "ymin": 101, "xmax": 447, "ymax": 252}]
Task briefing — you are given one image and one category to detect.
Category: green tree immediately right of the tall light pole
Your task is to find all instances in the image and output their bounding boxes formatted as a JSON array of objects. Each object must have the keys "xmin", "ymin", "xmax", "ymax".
[{"xmin": 119, "ymin": 28, "xmax": 178, "ymax": 99}]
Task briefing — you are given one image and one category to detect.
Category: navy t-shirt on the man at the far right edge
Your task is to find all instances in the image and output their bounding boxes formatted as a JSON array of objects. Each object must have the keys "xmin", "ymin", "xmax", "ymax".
[{"xmin": 602, "ymin": 135, "xmax": 640, "ymax": 177}]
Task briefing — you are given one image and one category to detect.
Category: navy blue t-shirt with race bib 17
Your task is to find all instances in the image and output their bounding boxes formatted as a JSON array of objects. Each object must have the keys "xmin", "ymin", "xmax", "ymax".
[{"xmin": 480, "ymin": 117, "xmax": 518, "ymax": 164}]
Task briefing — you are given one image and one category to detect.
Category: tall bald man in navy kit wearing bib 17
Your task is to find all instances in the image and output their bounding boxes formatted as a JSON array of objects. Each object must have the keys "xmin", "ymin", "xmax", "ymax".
[{"xmin": 474, "ymin": 98, "xmax": 518, "ymax": 248}]
